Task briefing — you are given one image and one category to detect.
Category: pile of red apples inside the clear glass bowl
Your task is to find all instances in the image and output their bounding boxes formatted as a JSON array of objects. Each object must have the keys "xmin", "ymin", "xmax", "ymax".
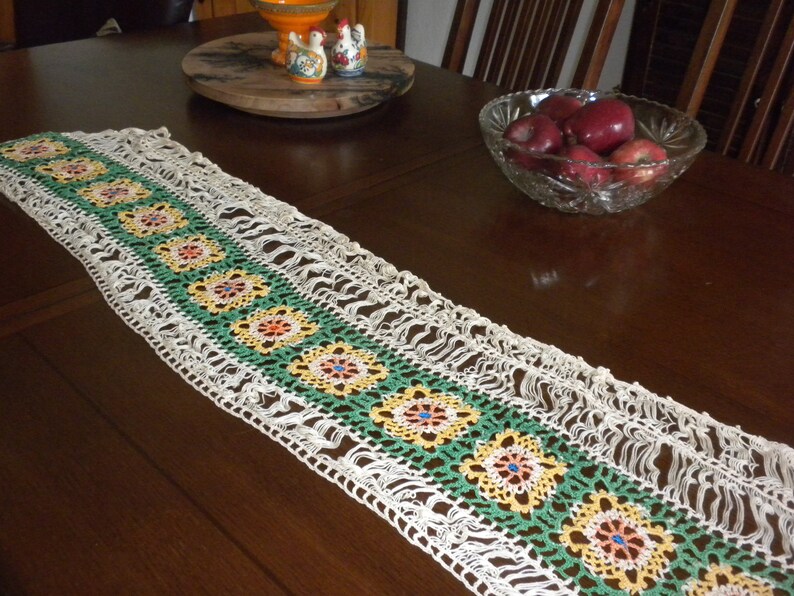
[{"xmin": 503, "ymin": 95, "xmax": 667, "ymax": 186}]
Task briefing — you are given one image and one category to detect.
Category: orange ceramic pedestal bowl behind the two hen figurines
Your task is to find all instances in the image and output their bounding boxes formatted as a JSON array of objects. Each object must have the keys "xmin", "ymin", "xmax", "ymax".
[{"xmin": 249, "ymin": 0, "xmax": 337, "ymax": 66}]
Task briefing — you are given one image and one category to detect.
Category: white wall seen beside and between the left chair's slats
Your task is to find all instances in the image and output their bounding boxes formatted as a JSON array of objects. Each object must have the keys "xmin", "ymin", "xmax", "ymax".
[{"xmin": 405, "ymin": 0, "xmax": 635, "ymax": 89}]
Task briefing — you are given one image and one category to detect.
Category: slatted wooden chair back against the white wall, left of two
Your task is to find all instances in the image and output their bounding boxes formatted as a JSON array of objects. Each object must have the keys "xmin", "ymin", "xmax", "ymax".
[{"xmin": 442, "ymin": 0, "xmax": 625, "ymax": 90}]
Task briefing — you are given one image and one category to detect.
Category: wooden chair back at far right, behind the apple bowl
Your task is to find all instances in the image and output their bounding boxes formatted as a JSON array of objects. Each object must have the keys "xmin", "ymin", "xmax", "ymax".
[{"xmin": 676, "ymin": 0, "xmax": 794, "ymax": 175}]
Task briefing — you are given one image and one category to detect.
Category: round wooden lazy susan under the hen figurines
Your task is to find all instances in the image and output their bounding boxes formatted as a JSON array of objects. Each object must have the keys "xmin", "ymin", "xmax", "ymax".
[{"xmin": 182, "ymin": 31, "xmax": 414, "ymax": 118}]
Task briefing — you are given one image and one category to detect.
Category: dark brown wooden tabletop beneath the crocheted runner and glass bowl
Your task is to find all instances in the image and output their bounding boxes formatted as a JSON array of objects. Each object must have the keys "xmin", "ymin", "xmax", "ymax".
[{"xmin": 0, "ymin": 15, "xmax": 794, "ymax": 594}]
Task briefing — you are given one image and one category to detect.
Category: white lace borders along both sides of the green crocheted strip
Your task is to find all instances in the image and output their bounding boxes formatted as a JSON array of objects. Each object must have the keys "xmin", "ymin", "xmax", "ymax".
[{"xmin": 0, "ymin": 129, "xmax": 794, "ymax": 594}]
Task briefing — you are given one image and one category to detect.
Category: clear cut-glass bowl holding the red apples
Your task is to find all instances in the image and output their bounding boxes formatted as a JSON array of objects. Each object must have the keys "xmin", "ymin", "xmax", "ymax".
[{"xmin": 480, "ymin": 89, "xmax": 706, "ymax": 214}]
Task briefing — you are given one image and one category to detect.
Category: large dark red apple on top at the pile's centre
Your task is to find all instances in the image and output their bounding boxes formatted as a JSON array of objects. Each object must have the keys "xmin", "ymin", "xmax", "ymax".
[{"xmin": 562, "ymin": 97, "xmax": 634, "ymax": 155}]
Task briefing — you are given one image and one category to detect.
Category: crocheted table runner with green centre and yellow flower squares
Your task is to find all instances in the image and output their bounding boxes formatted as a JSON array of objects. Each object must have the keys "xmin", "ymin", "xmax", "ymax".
[{"xmin": 0, "ymin": 129, "xmax": 794, "ymax": 595}]
